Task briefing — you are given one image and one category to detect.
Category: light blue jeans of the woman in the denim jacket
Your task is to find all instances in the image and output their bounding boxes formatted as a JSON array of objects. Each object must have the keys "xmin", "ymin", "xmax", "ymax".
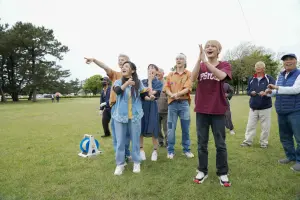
[{"xmin": 114, "ymin": 120, "xmax": 141, "ymax": 165}]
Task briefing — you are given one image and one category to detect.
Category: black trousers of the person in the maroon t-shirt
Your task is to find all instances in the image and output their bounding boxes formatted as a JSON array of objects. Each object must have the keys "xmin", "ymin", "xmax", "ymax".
[{"xmin": 196, "ymin": 113, "xmax": 228, "ymax": 176}]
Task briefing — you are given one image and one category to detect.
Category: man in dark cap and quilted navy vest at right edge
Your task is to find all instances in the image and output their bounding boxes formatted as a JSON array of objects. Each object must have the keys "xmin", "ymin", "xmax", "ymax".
[{"xmin": 266, "ymin": 54, "xmax": 300, "ymax": 172}]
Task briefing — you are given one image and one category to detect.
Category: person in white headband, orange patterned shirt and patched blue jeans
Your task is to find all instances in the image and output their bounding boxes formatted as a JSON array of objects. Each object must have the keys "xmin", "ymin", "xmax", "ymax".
[{"xmin": 164, "ymin": 53, "xmax": 194, "ymax": 159}]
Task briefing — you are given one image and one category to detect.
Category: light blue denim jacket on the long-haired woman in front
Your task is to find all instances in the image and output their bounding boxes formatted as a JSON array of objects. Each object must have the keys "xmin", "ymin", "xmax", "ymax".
[{"xmin": 112, "ymin": 79, "xmax": 145, "ymax": 123}]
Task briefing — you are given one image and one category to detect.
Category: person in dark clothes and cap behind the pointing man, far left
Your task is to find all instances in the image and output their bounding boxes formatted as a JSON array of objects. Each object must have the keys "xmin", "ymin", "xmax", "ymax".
[{"xmin": 100, "ymin": 77, "xmax": 111, "ymax": 137}]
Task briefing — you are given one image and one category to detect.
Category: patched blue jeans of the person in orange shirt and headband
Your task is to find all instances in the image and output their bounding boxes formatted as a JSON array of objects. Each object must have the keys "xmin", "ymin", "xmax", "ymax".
[{"xmin": 168, "ymin": 100, "xmax": 191, "ymax": 154}]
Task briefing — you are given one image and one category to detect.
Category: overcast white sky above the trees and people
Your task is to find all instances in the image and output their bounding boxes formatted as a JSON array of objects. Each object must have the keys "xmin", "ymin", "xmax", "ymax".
[{"xmin": 0, "ymin": 0, "xmax": 300, "ymax": 80}]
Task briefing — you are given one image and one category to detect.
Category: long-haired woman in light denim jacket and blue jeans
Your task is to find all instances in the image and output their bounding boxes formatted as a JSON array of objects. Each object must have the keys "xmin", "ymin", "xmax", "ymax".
[{"xmin": 112, "ymin": 61, "xmax": 147, "ymax": 175}]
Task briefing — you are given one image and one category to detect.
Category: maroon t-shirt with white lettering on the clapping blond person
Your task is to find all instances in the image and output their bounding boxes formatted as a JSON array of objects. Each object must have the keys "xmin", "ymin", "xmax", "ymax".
[{"xmin": 195, "ymin": 61, "xmax": 232, "ymax": 115}]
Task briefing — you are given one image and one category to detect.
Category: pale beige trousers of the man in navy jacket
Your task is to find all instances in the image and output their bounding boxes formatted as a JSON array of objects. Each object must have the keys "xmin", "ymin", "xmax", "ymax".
[{"xmin": 244, "ymin": 108, "xmax": 272, "ymax": 145}]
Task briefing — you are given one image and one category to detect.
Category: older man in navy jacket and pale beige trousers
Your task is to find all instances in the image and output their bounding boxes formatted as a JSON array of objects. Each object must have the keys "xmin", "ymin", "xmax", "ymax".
[{"xmin": 241, "ymin": 61, "xmax": 275, "ymax": 148}]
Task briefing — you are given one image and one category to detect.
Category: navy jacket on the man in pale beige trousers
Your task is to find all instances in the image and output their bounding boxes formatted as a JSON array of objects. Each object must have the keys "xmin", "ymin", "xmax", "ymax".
[{"xmin": 247, "ymin": 74, "xmax": 275, "ymax": 110}]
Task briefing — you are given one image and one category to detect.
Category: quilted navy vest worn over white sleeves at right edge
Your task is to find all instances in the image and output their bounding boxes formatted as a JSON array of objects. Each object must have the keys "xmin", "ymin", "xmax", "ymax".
[{"xmin": 275, "ymin": 69, "xmax": 300, "ymax": 114}]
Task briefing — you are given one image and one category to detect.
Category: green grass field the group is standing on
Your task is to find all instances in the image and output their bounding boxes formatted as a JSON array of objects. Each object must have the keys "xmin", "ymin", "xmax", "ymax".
[{"xmin": 0, "ymin": 96, "xmax": 300, "ymax": 200}]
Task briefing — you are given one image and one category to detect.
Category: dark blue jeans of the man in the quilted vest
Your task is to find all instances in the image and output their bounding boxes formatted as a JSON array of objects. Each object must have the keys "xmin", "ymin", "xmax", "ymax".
[{"xmin": 278, "ymin": 111, "xmax": 300, "ymax": 163}]
